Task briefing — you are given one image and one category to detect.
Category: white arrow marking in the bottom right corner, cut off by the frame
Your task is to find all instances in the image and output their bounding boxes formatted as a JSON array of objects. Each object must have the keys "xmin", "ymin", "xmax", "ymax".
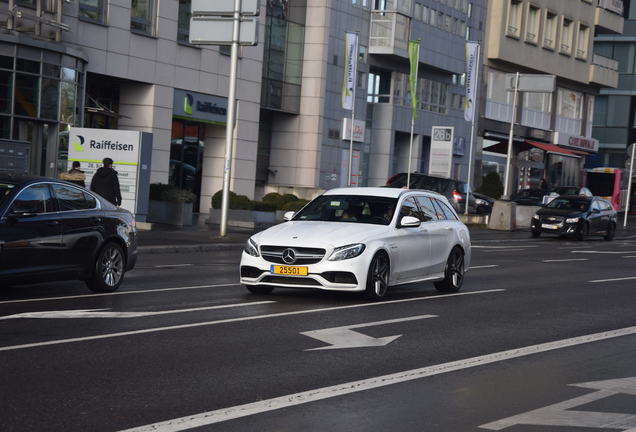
[{"xmin": 479, "ymin": 377, "xmax": 636, "ymax": 432}]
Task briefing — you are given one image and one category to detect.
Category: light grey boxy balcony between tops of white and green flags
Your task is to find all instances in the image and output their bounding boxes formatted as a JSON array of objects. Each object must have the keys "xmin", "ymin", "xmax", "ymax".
[{"xmin": 369, "ymin": 11, "xmax": 411, "ymax": 57}]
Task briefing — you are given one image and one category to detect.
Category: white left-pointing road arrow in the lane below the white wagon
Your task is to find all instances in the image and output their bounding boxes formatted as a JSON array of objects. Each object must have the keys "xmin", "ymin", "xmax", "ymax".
[{"xmin": 300, "ymin": 315, "xmax": 437, "ymax": 351}]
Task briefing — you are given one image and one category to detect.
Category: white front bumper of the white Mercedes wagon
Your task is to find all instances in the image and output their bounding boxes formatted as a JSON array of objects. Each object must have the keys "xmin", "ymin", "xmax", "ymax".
[{"xmin": 240, "ymin": 251, "xmax": 371, "ymax": 291}]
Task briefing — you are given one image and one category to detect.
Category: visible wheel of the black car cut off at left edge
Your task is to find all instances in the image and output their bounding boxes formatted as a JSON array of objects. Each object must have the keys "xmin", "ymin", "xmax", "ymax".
[{"xmin": 86, "ymin": 242, "xmax": 126, "ymax": 292}]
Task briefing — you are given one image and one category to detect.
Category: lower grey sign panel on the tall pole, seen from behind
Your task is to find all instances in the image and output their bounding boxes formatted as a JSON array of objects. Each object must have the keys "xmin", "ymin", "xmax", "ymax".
[{"xmin": 190, "ymin": 16, "xmax": 258, "ymax": 46}]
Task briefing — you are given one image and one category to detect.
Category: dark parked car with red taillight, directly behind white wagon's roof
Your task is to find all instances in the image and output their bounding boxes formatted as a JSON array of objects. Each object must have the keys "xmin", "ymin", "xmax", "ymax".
[{"xmin": 386, "ymin": 173, "xmax": 477, "ymax": 214}]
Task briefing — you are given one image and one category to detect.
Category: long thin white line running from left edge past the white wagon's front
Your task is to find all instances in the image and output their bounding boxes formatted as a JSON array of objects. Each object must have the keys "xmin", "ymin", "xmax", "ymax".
[{"xmin": 0, "ymin": 289, "xmax": 505, "ymax": 352}]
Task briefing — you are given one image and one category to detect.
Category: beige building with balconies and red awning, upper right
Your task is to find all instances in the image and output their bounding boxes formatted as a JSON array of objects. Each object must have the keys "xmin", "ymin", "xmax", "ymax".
[{"xmin": 480, "ymin": 0, "xmax": 624, "ymax": 191}]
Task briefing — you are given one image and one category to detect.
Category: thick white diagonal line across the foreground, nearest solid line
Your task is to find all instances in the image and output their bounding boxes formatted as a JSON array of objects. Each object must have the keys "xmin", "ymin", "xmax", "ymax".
[{"xmin": 120, "ymin": 327, "xmax": 636, "ymax": 432}]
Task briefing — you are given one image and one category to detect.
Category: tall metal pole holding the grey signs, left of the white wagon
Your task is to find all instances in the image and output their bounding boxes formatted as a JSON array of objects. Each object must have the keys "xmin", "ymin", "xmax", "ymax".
[{"xmin": 219, "ymin": 0, "xmax": 241, "ymax": 237}]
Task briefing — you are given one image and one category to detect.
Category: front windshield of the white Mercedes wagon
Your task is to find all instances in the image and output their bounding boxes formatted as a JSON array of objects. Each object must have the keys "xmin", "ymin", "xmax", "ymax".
[{"xmin": 294, "ymin": 195, "xmax": 397, "ymax": 225}]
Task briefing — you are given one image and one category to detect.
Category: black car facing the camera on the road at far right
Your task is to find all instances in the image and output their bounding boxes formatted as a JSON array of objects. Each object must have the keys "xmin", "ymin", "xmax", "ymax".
[{"xmin": 531, "ymin": 195, "xmax": 617, "ymax": 241}]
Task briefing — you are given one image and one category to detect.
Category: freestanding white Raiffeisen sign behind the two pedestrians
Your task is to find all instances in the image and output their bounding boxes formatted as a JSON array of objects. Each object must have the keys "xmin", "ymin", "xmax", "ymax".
[{"xmin": 68, "ymin": 128, "xmax": 152, "ymax": 222}]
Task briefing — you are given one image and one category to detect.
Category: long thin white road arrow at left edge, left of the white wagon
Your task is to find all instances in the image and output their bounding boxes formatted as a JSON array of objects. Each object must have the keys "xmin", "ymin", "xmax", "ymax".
[{"xmin": 0, "ymin": 300, "xmax": 276, "ymax": 320}]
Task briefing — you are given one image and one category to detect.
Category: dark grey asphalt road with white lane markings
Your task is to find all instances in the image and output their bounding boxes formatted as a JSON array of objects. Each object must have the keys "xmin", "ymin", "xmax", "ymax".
[{"xmin": 0, "ymin": 233, "xmax": 636, "ymax": 432}]
